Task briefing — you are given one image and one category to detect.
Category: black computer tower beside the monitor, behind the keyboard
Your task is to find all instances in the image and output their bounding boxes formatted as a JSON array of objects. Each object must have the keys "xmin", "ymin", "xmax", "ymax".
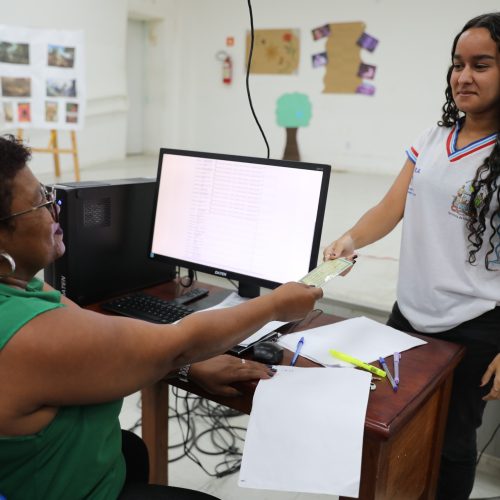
[{"xmin": 44, "ymin": 178, "xmax": 175, "ymax": 305}]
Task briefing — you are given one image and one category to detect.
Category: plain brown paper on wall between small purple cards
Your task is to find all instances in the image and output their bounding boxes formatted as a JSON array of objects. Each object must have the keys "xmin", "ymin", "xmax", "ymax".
[{"xmin": 323, "ymin": 22, "xmax": 365, "ymax": 94}]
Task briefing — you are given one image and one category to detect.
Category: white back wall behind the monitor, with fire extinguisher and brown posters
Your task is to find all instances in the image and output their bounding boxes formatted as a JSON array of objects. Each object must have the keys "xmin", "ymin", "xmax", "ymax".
[{"xmin": 146, "ymin": 0, "xmax": 498, "ymax": 173}]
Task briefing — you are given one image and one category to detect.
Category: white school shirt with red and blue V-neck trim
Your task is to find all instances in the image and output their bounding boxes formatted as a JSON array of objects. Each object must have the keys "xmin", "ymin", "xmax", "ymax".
[{"xmin": 397, "ymin": 122, "xmax": 500, "ymax": 333}]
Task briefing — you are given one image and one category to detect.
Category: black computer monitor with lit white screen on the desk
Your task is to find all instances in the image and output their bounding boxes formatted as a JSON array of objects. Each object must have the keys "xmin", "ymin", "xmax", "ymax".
[{"xmin": 150, "ymin": 148, "xmax": 330, "ymax": 297}]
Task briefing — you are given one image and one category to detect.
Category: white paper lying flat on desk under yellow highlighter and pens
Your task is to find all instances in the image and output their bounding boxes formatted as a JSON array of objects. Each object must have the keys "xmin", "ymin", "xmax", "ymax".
[{"xmin": 278, "ymin": 316, "xmax": 427, "ymax": 367}]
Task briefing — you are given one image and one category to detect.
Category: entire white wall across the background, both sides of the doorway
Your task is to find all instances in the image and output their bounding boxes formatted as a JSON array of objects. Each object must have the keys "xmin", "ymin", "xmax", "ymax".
[{"xmin": 0, "ymin": 0, "xmax": 498, "ymax": 177}]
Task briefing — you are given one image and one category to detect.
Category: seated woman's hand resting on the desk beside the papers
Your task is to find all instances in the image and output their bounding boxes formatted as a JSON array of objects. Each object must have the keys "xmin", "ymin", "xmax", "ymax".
[{"xmin": 189, "ymin": 354, "xmax": 274, "ymax": 396}]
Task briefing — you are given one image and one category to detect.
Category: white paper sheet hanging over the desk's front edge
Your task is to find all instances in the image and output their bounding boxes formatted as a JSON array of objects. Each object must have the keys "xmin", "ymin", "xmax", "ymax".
[{"xmin": 239, "ymin": 367, "xmax": 371, "ymax": 497}]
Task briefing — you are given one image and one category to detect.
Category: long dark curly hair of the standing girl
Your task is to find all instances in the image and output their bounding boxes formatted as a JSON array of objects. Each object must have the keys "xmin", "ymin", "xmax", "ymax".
[{"xmin": 438, "ymin": 12, "xmax": 500, "ymax": 269}]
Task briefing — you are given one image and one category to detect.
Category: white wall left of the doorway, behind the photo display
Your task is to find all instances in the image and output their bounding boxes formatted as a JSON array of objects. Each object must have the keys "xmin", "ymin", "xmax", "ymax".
[{"xmin": 0, "ymin": 0, "xmax": 131, "ymax": 173}]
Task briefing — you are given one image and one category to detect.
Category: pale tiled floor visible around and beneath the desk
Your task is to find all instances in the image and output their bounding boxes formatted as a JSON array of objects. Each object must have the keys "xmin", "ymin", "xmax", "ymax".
[{"xmin": 39, "ymin": 156, "xmax": 500, "ymax": 500}]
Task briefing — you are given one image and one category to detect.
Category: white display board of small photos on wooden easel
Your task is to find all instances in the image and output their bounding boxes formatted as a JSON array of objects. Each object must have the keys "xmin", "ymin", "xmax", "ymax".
[{"xmin": 0, "ymin": 25, "xmax": 85, "ymax": 130}]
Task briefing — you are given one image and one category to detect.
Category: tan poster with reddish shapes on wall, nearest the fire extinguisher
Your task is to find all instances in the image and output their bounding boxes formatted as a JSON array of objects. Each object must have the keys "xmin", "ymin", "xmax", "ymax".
[{"xmin": 245, "ymin": 29, "xmax": 300, "ymax": 75}]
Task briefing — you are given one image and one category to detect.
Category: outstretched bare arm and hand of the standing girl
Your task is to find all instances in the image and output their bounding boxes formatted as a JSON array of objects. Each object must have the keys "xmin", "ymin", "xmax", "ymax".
[{"xmin": 323, "ymin": 160, "xmax": 414, "ymax": 260}]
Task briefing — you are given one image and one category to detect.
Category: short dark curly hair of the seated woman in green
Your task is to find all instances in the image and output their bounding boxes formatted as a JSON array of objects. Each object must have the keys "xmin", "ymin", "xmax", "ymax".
[{"xmin": 0, "ymin": 134, "xmax": 31, "ymax": 226}]
